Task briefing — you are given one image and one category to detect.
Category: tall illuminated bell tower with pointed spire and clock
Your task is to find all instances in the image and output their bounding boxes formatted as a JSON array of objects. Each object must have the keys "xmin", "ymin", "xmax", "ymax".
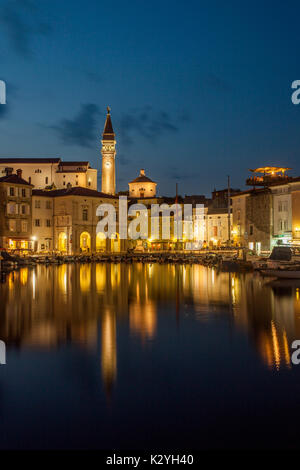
[{"xmin": 101, "ymin": 106, "xmax": 117, "ymax": 195}]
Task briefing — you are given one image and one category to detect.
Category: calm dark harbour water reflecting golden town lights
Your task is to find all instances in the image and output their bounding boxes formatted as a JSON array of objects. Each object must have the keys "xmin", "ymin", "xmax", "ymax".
[{"xmin": 0, "ymin": 264, "xmax": 300, "ymax": 449}]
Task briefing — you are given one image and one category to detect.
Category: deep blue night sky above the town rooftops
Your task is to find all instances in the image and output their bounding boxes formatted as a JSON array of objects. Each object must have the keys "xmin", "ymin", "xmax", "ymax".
[{"xmin": 0, "ymin": 0, "xmax": 300, "ymax": 195}]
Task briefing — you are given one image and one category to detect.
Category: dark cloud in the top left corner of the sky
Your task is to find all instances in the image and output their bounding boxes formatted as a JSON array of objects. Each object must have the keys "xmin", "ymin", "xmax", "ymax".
[{"xmin": 0, "ymin": 0, "xmax": 51, "ymax": 58}]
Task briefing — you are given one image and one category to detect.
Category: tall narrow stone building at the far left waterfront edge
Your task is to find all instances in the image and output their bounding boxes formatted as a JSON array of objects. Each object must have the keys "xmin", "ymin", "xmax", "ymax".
[{"xmin": 0, "ymin": 169, "xmax": 33, "ymax": 252}]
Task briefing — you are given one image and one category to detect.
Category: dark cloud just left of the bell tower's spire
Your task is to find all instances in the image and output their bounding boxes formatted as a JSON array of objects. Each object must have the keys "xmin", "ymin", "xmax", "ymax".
[{"xmin": 49, "ymin": 103, "xmax": 100, "ymax": 147}]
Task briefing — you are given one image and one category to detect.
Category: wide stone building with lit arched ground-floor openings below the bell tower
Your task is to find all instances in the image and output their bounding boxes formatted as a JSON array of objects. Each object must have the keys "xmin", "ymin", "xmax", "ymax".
[{"xmin": 33, "ymin": 187, "xmax": 125, "ymax": 255}]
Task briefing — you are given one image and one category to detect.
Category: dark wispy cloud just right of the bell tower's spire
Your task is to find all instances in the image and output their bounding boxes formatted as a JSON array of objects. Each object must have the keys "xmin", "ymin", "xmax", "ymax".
[{"xmin": 119, "ymin": 106, "xmax": 179, "ymax": 145}]
